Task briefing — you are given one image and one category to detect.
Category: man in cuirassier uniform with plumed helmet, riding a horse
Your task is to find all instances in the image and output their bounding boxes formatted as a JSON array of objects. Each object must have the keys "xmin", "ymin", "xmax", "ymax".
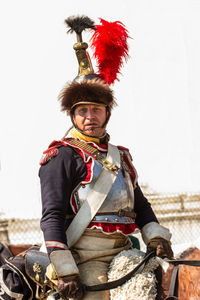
[{"xmin": 39, "ymin": 17, "xmax": 173, "ymax": 300}]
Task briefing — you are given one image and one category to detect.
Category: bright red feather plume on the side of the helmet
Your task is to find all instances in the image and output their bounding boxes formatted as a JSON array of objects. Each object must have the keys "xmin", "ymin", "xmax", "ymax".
[{"xmin": 91, "ymin": 19, "xmax": 129, "ymax": 84}]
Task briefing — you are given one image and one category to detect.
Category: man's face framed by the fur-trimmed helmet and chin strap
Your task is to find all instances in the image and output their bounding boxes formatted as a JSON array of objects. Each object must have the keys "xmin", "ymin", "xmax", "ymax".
[{"xmin": 73, "ymin": 104, "xmax": 107, "ymax": 137}]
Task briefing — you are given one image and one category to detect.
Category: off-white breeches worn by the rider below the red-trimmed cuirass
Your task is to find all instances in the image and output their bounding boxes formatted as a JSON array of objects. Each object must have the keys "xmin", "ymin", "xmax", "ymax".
[{"xmin": 71, "ymin": 229, "xmax": 131, "ymax": 300}]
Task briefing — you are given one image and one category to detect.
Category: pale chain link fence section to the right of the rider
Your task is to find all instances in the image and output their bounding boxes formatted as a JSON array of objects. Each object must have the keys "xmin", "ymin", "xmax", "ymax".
[{"xmin": 136, "ymin": 187, "xmax": 200, "ymax": 253}]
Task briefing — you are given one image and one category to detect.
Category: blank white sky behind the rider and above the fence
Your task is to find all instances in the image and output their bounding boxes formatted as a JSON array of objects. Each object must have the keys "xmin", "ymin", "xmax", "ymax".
[{"xmin": 0, "ymin": 0, "xmax": 200, "ymax": 215}]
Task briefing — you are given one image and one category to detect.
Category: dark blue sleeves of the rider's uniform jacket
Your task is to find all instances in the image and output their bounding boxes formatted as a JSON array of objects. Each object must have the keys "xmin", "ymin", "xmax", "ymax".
[{"xmin": 39, "ymin": 146, "xmax": 158, "ymax": 254}]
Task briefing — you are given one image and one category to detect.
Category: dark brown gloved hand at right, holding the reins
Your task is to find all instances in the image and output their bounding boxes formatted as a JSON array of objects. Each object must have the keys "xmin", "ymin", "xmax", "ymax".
[{"xmin": 147, "ymin": 237, "xmax": 174, "ymax": 259}]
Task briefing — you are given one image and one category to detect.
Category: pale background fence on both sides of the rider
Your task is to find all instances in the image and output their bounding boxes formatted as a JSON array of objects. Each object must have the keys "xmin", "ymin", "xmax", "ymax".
[{"xmin": 0, "ymin": 186, "xmax": 200, "ymax": 252}]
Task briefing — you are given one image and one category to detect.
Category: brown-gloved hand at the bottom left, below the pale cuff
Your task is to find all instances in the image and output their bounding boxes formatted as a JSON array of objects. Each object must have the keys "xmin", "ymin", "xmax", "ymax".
[{"xmin": 57, "ymin": 275, "xmax": 83, "ymax": 300}]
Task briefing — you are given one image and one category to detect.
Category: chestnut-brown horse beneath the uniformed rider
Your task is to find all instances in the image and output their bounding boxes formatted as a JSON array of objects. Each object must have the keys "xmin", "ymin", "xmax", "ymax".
[{"xmin": 0, "ymin": 243, "xmax": 200, "ymax": 300}]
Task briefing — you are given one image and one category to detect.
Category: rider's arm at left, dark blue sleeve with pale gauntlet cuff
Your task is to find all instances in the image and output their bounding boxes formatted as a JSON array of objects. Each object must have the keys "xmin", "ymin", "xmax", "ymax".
[{"xmin": 39, "ymin": 147, "xmax": 87, "ymax": 277}]
